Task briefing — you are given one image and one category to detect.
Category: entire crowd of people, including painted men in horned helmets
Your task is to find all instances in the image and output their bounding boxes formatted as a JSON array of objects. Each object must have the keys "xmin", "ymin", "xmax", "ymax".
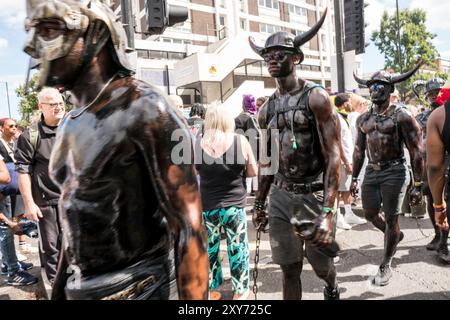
[{"xmin": 0, "ymin": 0, "xmax": 450, "ymax": 300}]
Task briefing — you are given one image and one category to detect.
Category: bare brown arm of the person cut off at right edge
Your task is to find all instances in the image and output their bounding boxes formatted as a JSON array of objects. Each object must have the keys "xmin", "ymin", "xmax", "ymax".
[{"xmin": 427, "ymin": 108, "xmax": 445, "ymax": 205}]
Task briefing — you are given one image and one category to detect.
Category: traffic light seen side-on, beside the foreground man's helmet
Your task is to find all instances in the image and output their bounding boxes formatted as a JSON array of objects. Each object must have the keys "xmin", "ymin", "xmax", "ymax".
[{"xmin": 146, "ymin": 0, "xmax": 188, "ymax": 34}]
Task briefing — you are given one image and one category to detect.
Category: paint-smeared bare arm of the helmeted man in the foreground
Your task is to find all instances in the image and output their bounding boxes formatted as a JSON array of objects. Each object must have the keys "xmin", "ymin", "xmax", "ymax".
[{"xmin": 136, "ymin": 97, "xmax": 209, "ymax": 300}]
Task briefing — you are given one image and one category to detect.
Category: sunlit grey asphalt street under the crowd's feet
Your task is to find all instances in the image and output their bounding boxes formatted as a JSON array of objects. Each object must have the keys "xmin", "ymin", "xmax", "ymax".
[{"xmin": 0, "ymin": 200, "xmax": 450, "ymax": 300}]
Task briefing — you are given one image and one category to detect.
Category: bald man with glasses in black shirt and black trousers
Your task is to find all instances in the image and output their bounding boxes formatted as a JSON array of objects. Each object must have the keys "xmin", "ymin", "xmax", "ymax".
[{"xmin": 15, "ymin": 88, "xmax": 65, "ymax": 283}]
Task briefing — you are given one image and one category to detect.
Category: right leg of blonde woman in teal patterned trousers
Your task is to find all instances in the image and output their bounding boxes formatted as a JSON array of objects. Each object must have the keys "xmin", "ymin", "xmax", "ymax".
[{"xmin": 221, "ymin": 207, "xmax": 250, "ymax": 299}]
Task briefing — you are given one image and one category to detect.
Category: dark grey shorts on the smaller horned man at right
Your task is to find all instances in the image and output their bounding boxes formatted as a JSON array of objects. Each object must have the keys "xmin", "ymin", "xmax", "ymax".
[{"xmin": 361, "ymin": 164, "xmax": 410, "ymax": 215}]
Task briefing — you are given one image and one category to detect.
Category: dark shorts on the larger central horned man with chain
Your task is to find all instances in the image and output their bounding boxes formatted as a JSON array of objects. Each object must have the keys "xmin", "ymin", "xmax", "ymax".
[{"xmin": 269, "ymin": 185, "xmax": 335, "ymax": 273}]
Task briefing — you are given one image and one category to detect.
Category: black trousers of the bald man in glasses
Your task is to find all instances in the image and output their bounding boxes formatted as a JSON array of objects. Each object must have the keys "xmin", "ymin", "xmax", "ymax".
[{"xmin": 39, "ymin": 205, "xmax": 61, "ymax": 284}]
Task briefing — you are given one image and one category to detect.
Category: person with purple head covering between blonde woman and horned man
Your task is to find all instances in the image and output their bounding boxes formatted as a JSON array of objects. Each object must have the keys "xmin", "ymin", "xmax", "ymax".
[{"xmin": 234, "ymin": 94, "xmax": 260, "ymax": 195}]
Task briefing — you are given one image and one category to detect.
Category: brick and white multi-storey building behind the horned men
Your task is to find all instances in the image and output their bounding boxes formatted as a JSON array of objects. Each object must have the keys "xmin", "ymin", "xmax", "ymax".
[{"xmin": 111, "ymin": 0, "xmax": 336, "ymax": 110}]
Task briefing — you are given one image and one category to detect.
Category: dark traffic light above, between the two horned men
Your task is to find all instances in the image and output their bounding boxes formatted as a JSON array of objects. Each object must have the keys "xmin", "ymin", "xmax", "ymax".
[{"xmin": 344, "ymin": 0, "xmax": 368, "ymax": 54}]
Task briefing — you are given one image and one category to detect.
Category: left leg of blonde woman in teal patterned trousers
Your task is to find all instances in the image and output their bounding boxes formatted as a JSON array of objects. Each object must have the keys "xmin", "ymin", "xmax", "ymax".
[{"xmin": 203, "ymin": 209, "xmax": 223, "ymax": 290}]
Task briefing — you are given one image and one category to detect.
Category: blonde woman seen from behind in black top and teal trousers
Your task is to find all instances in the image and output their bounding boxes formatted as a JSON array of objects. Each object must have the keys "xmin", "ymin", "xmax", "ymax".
[{"xmin": 196, "ymin": 105, "xmax": 257, "ymax": 300}]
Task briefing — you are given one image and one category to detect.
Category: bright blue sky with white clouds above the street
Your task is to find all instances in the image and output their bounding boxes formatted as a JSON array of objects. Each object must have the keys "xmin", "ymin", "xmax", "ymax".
[{"xmin": 0, "ymin": 0, "xmax": 450, "ymax": 119}]
